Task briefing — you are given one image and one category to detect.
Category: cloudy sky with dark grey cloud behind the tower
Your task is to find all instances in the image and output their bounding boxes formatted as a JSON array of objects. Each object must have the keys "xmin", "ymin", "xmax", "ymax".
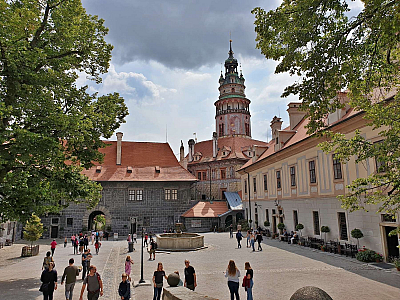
[{"xmin": 80, "ymin": 0, "xmax": 362, "ymax": 158}]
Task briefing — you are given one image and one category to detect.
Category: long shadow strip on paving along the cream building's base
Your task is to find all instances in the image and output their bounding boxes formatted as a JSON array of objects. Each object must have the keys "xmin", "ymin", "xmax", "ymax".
[{"xmin": 263, "ymin": 239, "xmax": 400, "ymax": 288}]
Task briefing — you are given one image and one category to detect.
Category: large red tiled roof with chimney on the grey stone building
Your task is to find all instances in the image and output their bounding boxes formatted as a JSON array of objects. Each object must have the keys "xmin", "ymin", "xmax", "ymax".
[{"xmin": 82, "ymin": 141, "xmax": 196, "ymax": 181}]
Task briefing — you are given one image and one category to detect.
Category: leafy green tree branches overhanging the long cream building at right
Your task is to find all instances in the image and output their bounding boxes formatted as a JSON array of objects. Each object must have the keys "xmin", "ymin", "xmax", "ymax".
[{"xmin": 252, "ymin": 0, "xmax": 400, "ymax": 231}]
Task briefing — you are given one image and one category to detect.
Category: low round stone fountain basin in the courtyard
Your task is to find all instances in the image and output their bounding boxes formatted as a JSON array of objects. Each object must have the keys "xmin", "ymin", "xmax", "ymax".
[{"xmin": 157, "ymin": 233, "xmax": 204, "ymax": 251}]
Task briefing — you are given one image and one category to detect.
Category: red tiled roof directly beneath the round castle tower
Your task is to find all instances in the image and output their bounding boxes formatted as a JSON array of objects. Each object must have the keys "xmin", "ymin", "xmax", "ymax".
[{"xmin": 186, "ymin": 136, "xmax": 268, "ymax": 165}]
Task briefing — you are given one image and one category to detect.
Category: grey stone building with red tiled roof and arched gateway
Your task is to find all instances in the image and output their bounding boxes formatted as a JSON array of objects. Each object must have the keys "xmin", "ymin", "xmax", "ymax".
[{"xmin": 42, "ymin": 133, "xmax": 196, "ymax": 237}]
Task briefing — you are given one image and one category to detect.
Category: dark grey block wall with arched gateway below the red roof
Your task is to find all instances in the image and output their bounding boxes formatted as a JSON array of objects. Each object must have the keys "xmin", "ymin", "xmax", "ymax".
[{"xmin": 42, "ymin": 182, "xmax": 196, "ymax": 237}]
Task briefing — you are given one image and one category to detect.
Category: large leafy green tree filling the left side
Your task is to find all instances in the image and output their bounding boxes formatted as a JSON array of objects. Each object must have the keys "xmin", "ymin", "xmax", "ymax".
[{"xmin": 0, "ymin": 0, "xmax": 128, "ymax": 221}]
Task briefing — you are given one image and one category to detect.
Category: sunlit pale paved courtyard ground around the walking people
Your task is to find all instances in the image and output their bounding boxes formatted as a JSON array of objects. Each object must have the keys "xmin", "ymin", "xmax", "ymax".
[{"xmin": 0, "ymin": 233, "xmax": 400, "ymax": 300}]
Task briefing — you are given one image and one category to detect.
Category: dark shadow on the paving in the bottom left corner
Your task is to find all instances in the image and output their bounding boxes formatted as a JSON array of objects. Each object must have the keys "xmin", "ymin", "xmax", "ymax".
[{"xmin": 0, "ymin": 278, "xmax": 42, "ymax": 299}]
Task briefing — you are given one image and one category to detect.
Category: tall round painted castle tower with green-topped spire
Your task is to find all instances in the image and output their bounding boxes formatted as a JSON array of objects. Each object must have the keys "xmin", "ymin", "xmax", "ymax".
[{"xmin": 214, "ymin": 40, "xmax": 251, "ymax": 138}]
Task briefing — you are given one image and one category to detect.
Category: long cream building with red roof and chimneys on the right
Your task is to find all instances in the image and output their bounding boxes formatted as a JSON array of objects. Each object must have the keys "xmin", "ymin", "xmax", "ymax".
[{"xmin": 239, "ymin": 93, "xmax": 400, "ymax": 258}]
